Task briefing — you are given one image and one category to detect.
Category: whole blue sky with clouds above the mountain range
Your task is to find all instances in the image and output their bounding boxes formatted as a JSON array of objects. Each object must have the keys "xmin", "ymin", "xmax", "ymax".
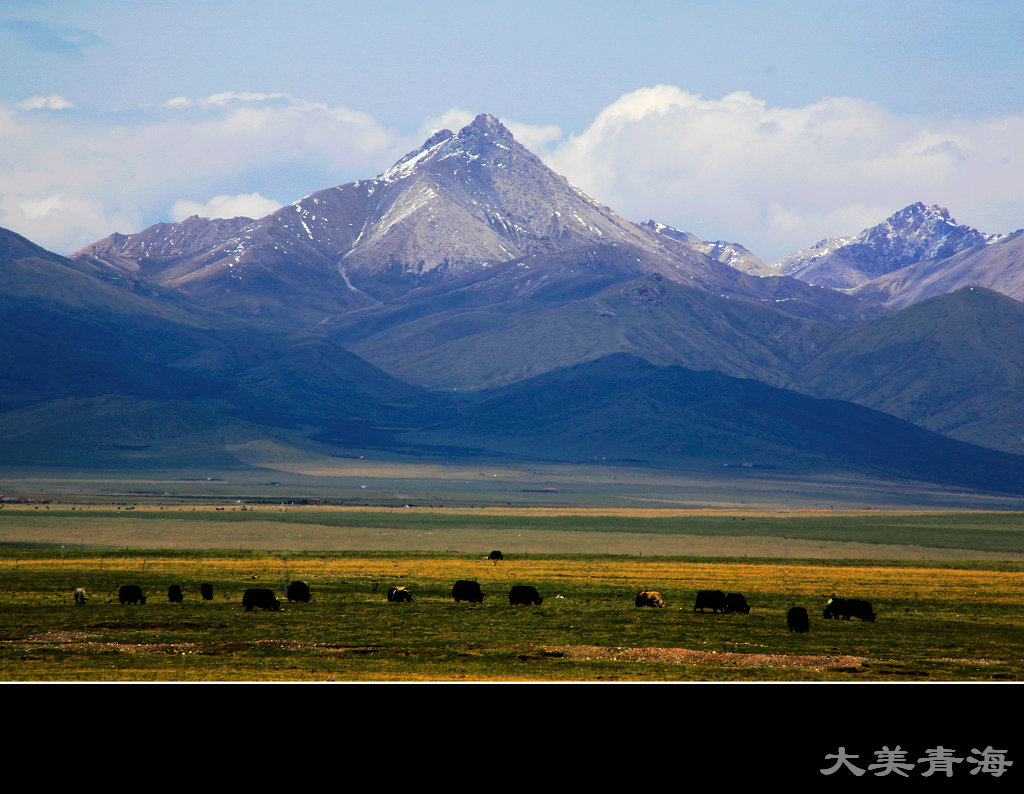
[{"xmin": 0, "ymin": 0, "xmax": 1024, "ymax": 261}]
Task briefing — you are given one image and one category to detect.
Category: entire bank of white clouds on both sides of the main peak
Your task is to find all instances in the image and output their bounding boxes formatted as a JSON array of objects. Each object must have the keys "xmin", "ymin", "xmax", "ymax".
[{"xmin": 0, "ymin": 85, "xmax": 1024, "ymax": 261}]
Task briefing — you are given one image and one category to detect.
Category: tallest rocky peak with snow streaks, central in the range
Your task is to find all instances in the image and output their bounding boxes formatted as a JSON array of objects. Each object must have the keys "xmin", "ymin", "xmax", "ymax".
[{"xmin": 70, "ymin": 114, "xmax": 774, "ymax": 323}]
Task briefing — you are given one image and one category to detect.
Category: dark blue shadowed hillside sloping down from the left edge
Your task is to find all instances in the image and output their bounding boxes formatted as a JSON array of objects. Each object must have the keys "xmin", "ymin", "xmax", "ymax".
[{"xmin": 0, "ymin": 226, "xmax": 436, "ymax": 446}]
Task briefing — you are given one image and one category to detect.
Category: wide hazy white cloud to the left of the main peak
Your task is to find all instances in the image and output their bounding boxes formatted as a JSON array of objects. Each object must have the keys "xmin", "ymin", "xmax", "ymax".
[{"xmin": 0, "ymin": 92, "xmax": 404, "ymax": 253}]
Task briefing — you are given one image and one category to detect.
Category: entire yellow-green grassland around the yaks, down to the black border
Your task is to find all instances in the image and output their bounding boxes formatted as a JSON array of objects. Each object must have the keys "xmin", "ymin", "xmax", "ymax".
[{"xmin": 0, "ymin": 505, "xmax": 1024, "ymax": 681}]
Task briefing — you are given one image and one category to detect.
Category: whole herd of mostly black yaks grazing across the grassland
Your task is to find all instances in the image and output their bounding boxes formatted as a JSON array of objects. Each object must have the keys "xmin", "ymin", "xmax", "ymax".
[{"xmin": 81, "ymin": 569, "xmax": 876, "ymax": 634}]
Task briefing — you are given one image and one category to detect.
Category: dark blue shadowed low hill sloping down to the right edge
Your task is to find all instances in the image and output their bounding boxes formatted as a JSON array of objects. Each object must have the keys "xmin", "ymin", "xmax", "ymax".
[{"xmin": 409, "ymin": 354, "xmax": 1024, "ymax": 493}]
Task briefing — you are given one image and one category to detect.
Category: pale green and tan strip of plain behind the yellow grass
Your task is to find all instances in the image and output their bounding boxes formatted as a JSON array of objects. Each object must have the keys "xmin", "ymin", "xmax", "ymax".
[{"xmin": 0, "ymin": 501, "xmax": 1024, "ymax": 560}]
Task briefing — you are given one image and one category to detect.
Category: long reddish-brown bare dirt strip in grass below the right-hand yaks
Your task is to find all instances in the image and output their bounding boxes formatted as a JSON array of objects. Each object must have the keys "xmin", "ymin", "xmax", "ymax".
[{"xmin": 545, "ymin": 645, "xmax": 872, "ymax": 670}]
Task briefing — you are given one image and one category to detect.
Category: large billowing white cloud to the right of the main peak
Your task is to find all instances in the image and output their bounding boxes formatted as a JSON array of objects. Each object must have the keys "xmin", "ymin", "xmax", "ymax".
[{"xmin": 545, "ymin": 85, "xmax": 1024, "ymax": 261}]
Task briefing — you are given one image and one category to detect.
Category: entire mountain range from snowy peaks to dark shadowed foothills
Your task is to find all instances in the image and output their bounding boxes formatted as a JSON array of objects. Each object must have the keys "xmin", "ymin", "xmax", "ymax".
[{"xmin": 0, "ymin": 115, "xmax": 1024, "ymax": 493}]
